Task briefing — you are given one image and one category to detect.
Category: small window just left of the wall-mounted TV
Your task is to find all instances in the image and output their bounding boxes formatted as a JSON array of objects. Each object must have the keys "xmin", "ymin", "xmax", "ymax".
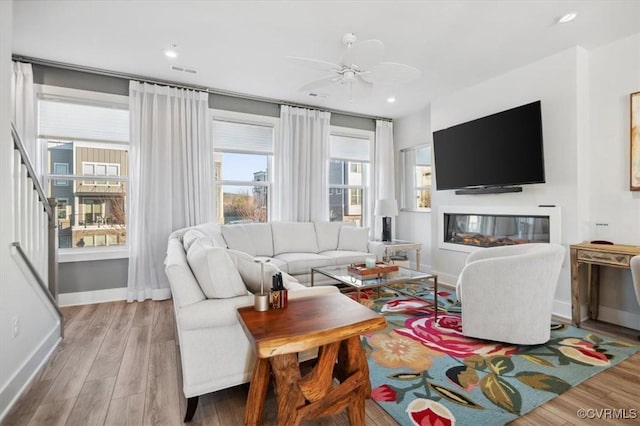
[{"xmin": 400, "ymin": 145, "xmax": 431, "ymax": 210}]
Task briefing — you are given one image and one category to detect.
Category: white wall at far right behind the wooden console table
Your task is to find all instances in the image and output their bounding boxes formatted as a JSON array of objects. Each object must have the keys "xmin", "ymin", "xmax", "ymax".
[{"xmin": 584, "ymin": 34, "xmax": 640, "ymax": 329}]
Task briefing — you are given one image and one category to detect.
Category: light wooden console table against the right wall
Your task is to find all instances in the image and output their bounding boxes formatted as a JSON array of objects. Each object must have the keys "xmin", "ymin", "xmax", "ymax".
[{"xmin": 570, "ymin": 243, "xmax": 640, "ymax": 327}]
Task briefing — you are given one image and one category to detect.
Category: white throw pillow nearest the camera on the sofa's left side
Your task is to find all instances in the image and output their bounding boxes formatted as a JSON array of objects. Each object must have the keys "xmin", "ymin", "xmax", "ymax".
[{"xmin": 187, "ymin": 243, "xmax": 247, "ymax": 299}]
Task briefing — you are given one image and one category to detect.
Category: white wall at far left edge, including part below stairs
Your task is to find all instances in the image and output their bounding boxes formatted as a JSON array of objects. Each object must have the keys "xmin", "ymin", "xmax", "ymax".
[{"xmin": 0, "ymin": 1, "xmax": 60, "ymax": 419}]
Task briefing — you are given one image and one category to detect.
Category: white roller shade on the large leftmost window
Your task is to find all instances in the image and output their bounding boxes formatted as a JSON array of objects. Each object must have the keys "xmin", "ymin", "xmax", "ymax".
[{"xmin": 38, "ymin": 99, "xmax": 129, "ymax": 142}]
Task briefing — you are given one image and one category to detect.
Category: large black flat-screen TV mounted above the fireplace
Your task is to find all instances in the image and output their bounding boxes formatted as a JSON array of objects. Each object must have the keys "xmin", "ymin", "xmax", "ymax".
[{"xmin": 433, "ymin": 101, "xmax": 545, "ymax": 190}]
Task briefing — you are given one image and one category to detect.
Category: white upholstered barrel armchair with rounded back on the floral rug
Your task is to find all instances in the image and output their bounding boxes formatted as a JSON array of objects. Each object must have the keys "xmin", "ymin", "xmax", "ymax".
[{"xmin": 456, "ymin": 243, "xmax": 566, "ymax": 345}]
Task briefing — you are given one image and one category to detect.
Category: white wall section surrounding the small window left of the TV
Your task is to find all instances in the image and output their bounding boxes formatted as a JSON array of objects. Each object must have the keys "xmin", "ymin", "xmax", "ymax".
[{"xmin": 393, "ymin": 106, "xmax": 432, "ymax": 271}]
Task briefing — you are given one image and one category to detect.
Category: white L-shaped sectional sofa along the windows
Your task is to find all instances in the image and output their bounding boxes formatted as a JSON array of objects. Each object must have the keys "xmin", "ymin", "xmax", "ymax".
[{"xmin": 165, "ymin": 223, "xmax": 381, "ymax": 421}]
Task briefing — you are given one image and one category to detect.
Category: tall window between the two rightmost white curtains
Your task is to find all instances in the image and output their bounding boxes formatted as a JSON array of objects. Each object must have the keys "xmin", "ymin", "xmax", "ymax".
[{"xmin": 329, "ymin": 128, "xmax": 373, "ymax": 226}]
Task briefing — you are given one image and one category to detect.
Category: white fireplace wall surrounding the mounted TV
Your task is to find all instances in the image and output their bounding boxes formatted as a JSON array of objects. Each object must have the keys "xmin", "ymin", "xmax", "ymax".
[{"xmin": 431, "ymin": 48, "xmax": 587, "ymax": 317}]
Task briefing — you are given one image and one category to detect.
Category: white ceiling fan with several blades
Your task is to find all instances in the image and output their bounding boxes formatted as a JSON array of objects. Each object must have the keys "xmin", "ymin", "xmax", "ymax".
[{"xmin": 286, "ymin": 33, "xmax": 421, "ymax": 99}]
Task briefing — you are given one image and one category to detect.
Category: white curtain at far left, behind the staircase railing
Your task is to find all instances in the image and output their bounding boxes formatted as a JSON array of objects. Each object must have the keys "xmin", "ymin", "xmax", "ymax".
[{"xmin": 11, "ymin": 62, "xmax": 39, "ymax": 176}]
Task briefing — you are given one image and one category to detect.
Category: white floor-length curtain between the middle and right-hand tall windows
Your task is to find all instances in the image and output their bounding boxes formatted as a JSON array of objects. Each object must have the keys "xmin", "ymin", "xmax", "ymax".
[{"xmin": 273, "ymin": 105, "xmax": 331, "ymax": 222}]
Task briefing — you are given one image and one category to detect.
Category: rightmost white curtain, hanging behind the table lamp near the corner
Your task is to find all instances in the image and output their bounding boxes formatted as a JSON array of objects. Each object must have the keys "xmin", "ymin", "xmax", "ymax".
[{"xmin": 370, "ymin": 120, "xmax": 397, "ymax": 238}]
